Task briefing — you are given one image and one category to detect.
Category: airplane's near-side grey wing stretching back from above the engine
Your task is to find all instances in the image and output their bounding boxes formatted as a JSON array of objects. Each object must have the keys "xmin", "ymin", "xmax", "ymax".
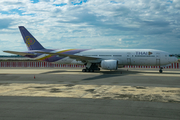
[{"xmin": 37, "ymin": 51, "xmax": 100, "ymax": 61}]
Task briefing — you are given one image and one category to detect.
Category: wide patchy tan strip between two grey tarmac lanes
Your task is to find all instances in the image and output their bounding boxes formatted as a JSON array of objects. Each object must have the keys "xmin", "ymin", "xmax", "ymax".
[{"xmin": 0, "ymin": 83, "xmax": 180, "ymax": 103}]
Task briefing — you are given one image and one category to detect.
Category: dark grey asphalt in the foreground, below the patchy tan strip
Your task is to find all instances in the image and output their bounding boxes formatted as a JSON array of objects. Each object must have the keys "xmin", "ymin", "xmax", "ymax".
[{"xmin": 0, "ymin": 96, "xmax": 180, "ymax": 120}]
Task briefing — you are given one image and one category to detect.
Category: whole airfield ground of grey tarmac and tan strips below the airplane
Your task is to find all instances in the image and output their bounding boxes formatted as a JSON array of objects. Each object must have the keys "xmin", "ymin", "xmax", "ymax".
[{"xmin": 0, "ymin": 68, "xmax": 180, "ymax": 120}]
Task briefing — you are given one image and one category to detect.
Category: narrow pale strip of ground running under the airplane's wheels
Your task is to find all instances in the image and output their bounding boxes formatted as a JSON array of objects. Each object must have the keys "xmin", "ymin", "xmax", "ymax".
[{"xmin": 0, "ymin": 68, "xmax": 180, "ymax": 77}]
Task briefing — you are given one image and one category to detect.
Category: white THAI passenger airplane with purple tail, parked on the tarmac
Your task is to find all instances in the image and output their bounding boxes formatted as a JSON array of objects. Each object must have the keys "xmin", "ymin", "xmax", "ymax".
[{"xmin": 3, "ymin": 26, "xmax": 178, "ymax": 73}]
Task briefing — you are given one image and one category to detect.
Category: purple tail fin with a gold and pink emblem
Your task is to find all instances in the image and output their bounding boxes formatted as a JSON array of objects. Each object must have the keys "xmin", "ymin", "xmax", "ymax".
[{"xmin": 19, "ymin": 26, "xmax": 44, "ymax": 50}]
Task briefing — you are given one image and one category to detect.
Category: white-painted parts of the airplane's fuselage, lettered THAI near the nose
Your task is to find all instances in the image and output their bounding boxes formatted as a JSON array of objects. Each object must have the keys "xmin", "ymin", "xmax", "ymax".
[{"xmin": 51, "ymin": 49, "xmax": 177, "ymax": 66}]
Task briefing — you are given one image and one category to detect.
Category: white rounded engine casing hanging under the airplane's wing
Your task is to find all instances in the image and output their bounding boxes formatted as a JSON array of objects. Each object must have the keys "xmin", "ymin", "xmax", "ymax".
[{"xmin": 101, "ymin": 60, "xmax": 118, "ymax": 70}]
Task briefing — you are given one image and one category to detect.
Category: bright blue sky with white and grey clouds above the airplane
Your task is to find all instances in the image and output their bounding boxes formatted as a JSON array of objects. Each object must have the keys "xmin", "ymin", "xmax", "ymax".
[{"xmin": 0, "ymin": 0, "xmax": 180, "ymax": 55}]
